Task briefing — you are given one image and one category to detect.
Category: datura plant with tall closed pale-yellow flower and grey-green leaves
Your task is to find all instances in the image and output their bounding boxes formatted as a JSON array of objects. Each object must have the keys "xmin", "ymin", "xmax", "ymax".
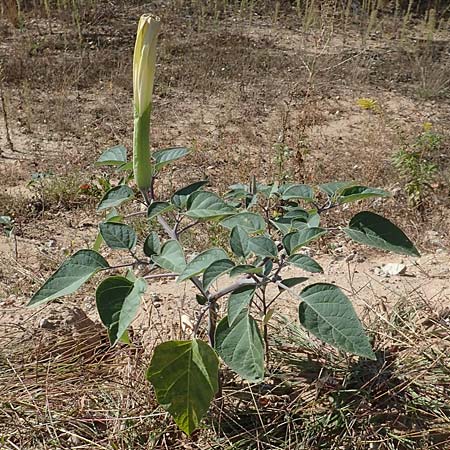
[{"xmin": 29, "ymin": 15, "xmax": 419, "ymax": 434}]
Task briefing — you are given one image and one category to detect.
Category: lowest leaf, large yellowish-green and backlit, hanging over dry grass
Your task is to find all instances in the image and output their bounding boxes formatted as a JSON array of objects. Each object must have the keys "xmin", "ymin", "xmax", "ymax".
[{"xmin": 147, "ymin": 339, "xmax": 219, "ymax": 435}]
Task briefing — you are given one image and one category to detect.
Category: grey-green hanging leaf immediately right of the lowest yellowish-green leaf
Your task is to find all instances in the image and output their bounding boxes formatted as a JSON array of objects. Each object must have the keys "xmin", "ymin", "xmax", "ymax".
[{"xmin": 215, "ymin": 310, "xmax": 264, "ymax": 382}]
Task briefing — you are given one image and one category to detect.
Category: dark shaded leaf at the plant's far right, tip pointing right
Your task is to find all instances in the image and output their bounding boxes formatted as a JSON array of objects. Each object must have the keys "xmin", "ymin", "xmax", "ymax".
[{"xmin": 344, "ymin": 211, "xmax": 420, "ymax": 256}]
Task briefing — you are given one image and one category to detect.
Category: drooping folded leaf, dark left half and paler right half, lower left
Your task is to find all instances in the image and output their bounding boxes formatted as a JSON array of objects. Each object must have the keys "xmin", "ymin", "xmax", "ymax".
[{"xmin": 95, "ymin": 276, "xmax": 147, "ymax": 345}]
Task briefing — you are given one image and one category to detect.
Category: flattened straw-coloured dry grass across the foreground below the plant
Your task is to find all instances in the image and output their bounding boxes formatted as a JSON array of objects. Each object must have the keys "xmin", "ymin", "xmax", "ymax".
[{"xmin": 0, "ymin": 299, "xmax": 450, "ymax": 450}]
